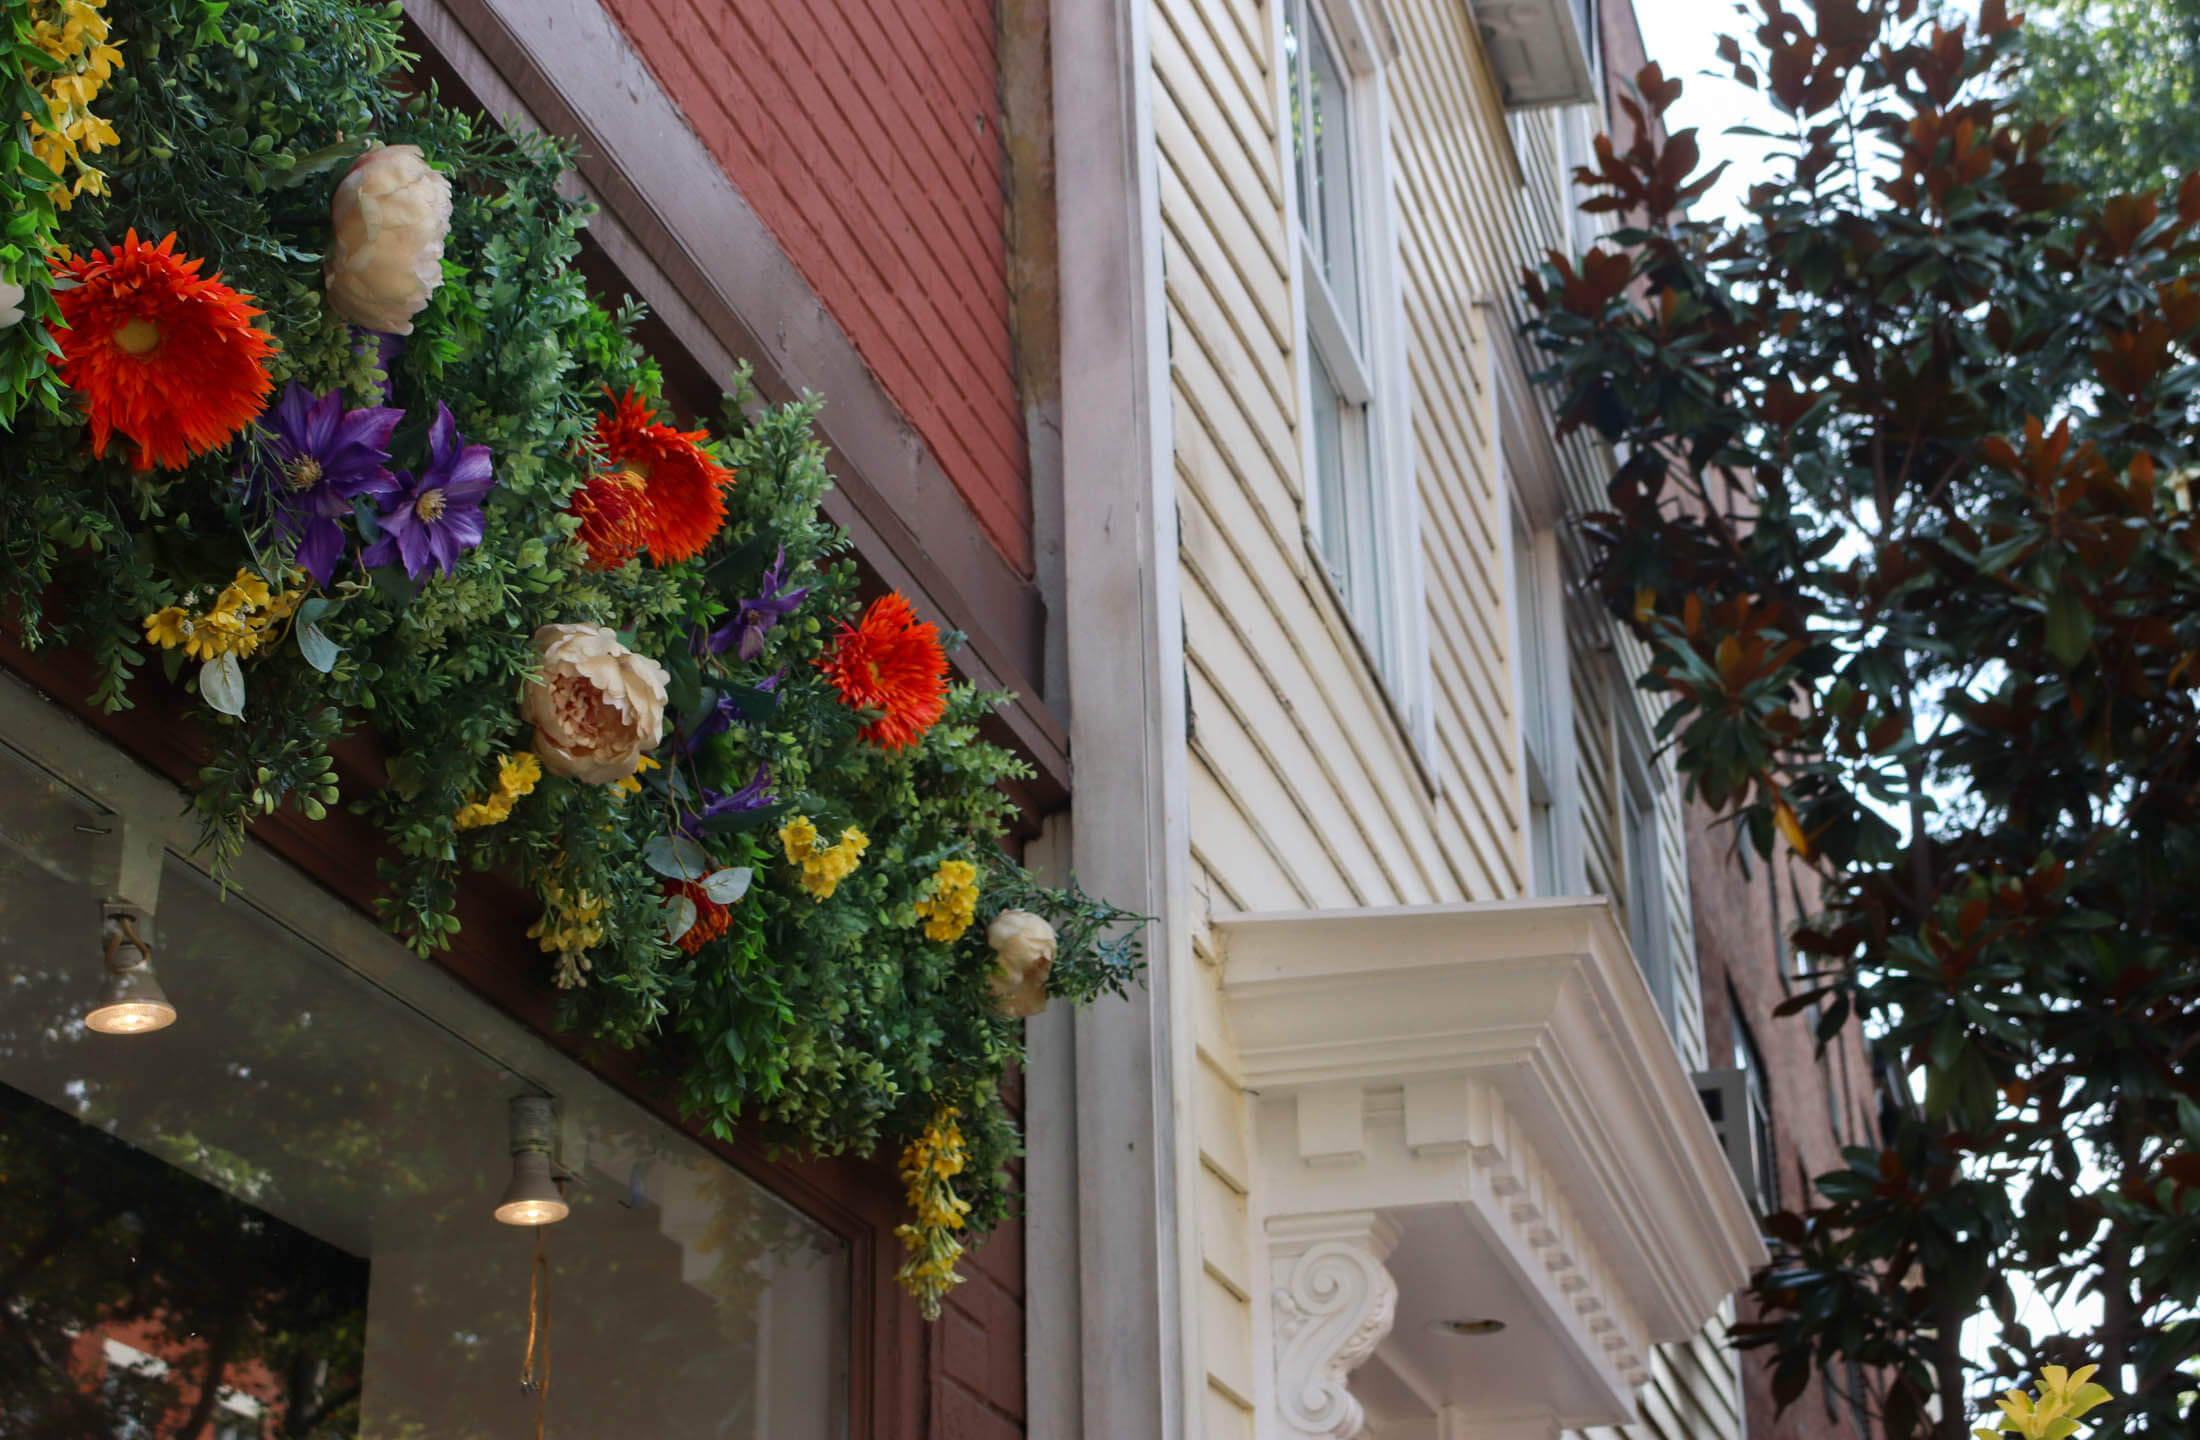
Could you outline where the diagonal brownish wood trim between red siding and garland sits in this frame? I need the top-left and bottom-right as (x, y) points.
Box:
(407, 0), (1069, 809)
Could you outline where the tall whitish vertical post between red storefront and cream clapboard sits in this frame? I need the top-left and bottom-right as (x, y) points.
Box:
(1027, 0), (1199, 1440)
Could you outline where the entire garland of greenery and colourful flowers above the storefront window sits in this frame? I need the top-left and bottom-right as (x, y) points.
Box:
(0, 0), (1140, 1315)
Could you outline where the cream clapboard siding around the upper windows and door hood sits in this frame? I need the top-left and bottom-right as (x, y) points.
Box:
(1148, 0), (1740, 1440)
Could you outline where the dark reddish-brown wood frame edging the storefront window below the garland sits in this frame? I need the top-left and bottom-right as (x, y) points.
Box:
(0, 629), (937, 1440)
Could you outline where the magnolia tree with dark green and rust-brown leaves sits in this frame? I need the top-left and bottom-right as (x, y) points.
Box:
(1527, 0), (2200, 1440)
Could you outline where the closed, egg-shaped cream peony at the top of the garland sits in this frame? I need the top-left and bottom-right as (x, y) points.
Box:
(321, 145), (451, 334)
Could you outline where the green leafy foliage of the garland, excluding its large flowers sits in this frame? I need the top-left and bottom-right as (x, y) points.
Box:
(0, 0), (1142, 1312)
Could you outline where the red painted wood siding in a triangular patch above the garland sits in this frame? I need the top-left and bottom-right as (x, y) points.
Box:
(603, 0), (1032, 574)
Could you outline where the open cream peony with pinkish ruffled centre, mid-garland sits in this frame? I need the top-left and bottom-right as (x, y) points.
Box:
(519, 624), (669, 785)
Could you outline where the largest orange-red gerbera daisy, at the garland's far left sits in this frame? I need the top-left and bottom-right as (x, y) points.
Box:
(53, 231), (275, 470)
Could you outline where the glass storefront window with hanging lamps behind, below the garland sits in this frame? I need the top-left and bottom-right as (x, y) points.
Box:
(0, 754), (849, 1440)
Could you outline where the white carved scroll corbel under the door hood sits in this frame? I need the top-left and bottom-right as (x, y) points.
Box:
(1267, 1211), (1397, 1440)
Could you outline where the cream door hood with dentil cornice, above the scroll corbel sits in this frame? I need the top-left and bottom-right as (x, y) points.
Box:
(1214, 899), (1767, 1425)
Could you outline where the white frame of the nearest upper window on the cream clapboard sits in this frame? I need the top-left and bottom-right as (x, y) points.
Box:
(1274, 0), (1434, 756)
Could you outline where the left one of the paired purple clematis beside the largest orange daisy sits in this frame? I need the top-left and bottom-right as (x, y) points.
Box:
(251, 380), (405, 585)
